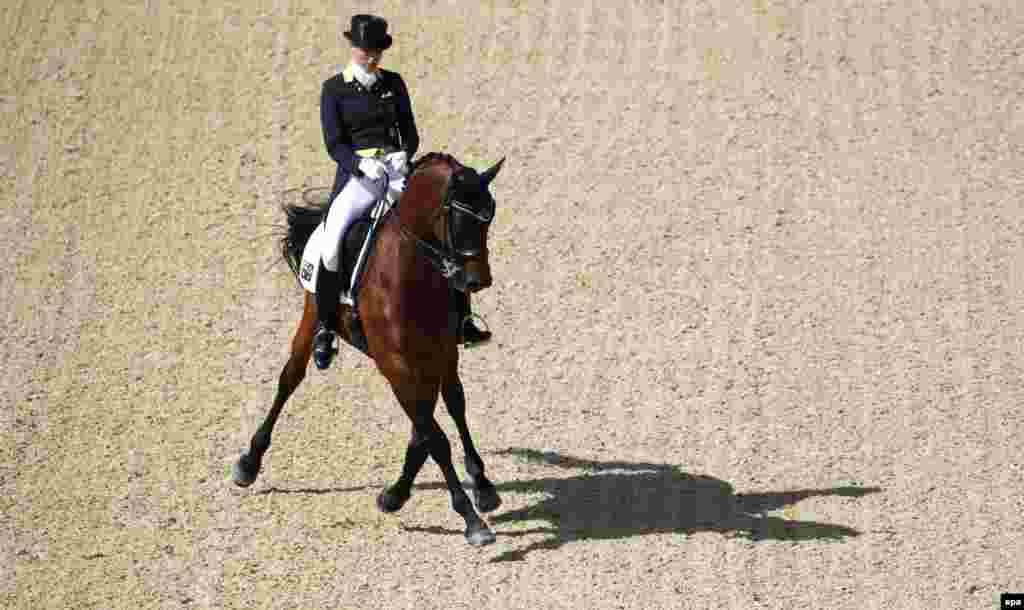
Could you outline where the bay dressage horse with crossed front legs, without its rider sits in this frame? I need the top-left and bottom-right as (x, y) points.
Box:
(232, 153), (505, 546)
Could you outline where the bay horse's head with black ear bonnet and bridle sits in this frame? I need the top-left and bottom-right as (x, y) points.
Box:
(405, 157), (505, 293)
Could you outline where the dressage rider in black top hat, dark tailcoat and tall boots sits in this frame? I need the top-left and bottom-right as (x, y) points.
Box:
(313, 14), (490, 369)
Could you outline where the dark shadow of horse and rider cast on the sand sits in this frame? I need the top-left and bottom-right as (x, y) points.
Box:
(256, 448), (881, 562)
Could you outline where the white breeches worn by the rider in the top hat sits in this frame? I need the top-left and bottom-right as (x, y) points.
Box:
(321, 166), (406, 271)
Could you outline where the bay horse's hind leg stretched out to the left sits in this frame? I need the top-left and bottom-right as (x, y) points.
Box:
(232, 293), (316, 487)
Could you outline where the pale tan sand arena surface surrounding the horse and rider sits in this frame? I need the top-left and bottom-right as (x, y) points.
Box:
(0, 0), (1024, 609)
